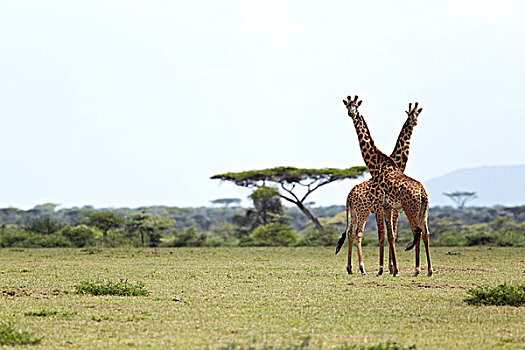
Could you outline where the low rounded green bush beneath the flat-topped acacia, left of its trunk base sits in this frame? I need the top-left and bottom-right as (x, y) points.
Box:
(241, 222), (299, 247)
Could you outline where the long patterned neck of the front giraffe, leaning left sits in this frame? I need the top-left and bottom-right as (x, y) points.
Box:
(352, 115), (392, 177)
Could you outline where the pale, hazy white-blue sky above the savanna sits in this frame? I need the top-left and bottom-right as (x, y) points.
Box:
(0, 0), (525, 208)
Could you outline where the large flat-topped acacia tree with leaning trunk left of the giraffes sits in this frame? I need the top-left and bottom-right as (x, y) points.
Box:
(211, 166), (368, 231)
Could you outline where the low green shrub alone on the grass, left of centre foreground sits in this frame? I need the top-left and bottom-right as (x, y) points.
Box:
(75, 279), (150, 296)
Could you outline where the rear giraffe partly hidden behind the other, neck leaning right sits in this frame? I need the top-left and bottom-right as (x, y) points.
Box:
(335, 102), (423, 275)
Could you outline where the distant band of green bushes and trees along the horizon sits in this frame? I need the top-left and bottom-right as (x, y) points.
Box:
(0, 204), (525, 247)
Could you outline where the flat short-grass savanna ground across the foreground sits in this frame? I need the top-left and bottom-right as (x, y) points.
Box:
(0, 247), (525, 349)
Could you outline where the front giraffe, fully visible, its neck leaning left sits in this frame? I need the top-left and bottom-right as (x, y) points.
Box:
(343, 96), (433, 277)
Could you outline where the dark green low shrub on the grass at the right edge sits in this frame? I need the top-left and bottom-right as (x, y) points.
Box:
(464, 283), (525, 306)
